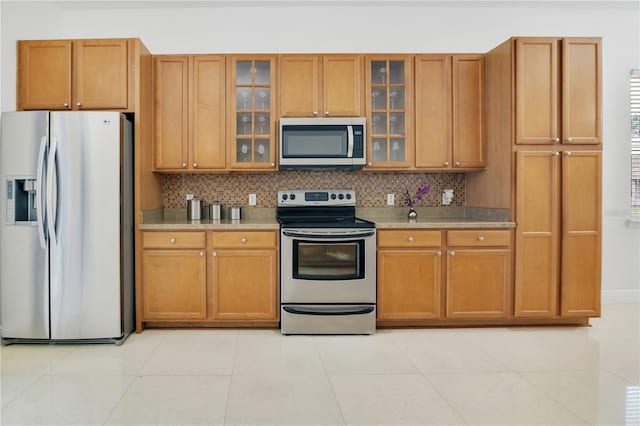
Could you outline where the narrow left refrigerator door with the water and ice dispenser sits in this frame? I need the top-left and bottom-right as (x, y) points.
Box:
(0, 111), (49, 339)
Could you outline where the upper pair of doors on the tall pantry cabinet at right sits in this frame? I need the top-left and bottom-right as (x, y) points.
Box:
(515, 37), (602, 145)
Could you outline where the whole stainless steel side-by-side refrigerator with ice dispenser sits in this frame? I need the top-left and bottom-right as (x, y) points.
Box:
(0, 111), (134, 344)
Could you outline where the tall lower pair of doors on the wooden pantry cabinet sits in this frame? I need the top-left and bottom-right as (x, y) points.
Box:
(515, 151), (601, 317)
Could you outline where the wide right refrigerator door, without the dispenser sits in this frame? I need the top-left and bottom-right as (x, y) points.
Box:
(47, 112), (123, 340)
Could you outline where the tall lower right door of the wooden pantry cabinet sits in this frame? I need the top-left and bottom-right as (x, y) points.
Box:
(560, 151), (602, 317)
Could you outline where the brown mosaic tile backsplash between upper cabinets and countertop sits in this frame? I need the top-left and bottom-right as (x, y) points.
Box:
(162, 171), (465, 208)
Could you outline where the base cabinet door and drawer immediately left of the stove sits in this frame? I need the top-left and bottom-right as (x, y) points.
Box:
(211, 231), (279, 321)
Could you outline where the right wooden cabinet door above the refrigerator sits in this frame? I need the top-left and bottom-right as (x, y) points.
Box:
(73, 39), (129, 110)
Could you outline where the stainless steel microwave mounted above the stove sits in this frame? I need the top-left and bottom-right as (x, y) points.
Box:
(279, 117), (366, 170)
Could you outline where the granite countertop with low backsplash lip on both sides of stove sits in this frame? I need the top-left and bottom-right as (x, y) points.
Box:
(139, 207), (516, 231)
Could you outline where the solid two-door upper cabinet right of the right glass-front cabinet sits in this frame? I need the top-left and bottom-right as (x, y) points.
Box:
(415, 55), (486, 170)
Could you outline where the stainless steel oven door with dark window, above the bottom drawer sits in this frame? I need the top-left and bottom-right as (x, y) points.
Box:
(280, 228), (376, 303)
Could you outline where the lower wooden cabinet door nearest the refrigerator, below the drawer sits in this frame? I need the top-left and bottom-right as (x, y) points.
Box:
(142, 250), (207, 320)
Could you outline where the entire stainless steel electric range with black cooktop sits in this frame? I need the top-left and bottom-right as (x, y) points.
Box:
(277, 190), (376, 334)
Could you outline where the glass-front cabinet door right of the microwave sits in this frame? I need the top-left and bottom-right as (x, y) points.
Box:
(366, 55), (413, 169)
